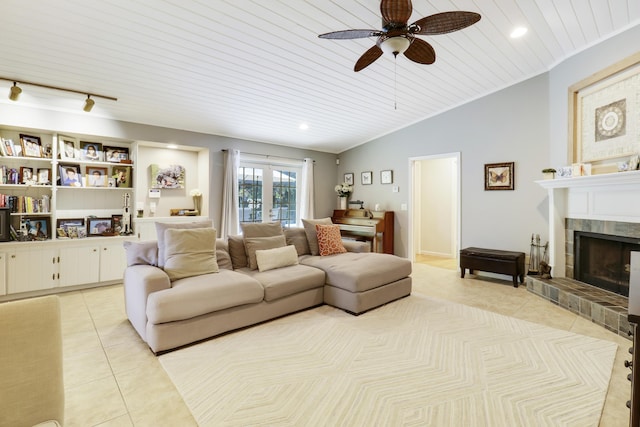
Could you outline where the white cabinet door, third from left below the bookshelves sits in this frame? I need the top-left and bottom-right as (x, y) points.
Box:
(60, 246), (100, 286)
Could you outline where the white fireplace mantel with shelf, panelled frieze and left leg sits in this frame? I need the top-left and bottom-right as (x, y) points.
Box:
(536, 171), (640, 277)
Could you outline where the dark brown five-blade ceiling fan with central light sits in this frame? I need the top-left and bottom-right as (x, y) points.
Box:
(318, 0), (480, 72)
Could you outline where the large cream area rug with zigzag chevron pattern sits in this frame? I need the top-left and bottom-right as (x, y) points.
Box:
(160, 294), (617, 427)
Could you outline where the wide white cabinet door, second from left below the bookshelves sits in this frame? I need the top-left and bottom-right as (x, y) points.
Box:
(7, 249), (58, 294)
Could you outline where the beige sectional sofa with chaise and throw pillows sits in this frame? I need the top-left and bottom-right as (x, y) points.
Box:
(124, 220), (411, 353)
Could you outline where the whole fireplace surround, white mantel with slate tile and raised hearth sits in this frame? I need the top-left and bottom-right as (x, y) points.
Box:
(527, 171), (640, 338)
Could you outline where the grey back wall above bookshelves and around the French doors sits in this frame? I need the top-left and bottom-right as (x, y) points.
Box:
(0, 100), (337, 232)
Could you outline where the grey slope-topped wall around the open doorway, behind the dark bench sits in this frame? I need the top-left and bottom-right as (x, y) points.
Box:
(339, 74), (549, 257)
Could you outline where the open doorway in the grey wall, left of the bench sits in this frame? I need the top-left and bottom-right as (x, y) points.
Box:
(409, 152), (460, 268)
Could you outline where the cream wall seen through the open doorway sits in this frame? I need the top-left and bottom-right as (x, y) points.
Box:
(414, 157), (457, 258)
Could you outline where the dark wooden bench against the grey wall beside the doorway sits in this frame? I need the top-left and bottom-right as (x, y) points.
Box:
(460, 248), (524, 288)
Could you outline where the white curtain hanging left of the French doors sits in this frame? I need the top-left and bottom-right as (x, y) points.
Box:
(220, 150), (240, 239)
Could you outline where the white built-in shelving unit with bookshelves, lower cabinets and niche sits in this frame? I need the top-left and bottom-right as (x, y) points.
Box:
(0, 125), (209, 301)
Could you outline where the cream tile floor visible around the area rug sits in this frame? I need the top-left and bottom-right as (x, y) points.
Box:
(60, 256), (630, 427)
